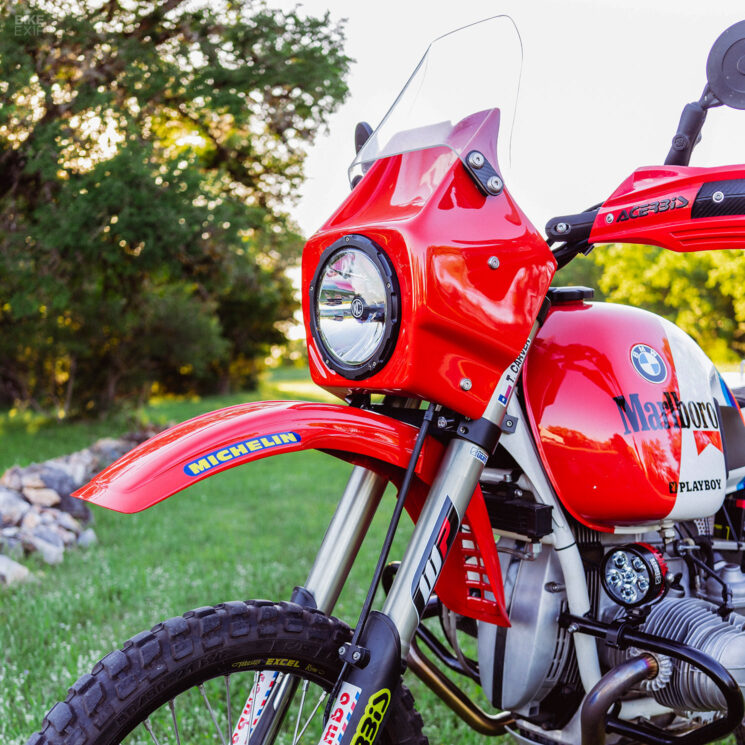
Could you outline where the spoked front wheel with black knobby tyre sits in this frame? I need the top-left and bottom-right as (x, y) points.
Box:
(27, 601), (427, 745)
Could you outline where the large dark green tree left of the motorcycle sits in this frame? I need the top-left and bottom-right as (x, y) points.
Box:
(0, 0), (349, 413)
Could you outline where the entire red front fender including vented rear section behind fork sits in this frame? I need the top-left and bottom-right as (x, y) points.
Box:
(73, 401), (509, 626)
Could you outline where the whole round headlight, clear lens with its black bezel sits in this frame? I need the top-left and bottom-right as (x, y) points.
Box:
(310, 235), (399, 380)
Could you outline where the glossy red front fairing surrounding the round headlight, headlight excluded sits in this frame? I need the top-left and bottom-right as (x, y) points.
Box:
(303, 111), (556, 418)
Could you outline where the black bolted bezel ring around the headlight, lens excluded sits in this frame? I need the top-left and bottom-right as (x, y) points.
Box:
(308, 234), (401, 380)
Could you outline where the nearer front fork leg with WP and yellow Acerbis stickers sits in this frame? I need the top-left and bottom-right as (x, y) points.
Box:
(319, 439), (488, 745)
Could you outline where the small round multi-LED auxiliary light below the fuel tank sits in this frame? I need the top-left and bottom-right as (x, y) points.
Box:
(600, 543), (667, 608)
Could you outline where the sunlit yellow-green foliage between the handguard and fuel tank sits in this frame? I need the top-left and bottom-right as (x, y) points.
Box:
(555, 244), (745, 363)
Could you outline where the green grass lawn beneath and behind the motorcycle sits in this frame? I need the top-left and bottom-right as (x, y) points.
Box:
(0, 373), (732, 745)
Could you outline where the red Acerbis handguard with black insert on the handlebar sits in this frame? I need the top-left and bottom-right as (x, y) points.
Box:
(589, 165), (745, 251)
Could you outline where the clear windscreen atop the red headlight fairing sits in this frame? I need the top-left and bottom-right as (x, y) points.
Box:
(349, 16), (522, 183)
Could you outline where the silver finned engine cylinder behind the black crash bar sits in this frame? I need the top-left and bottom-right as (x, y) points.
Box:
(608, 598), (745, 714)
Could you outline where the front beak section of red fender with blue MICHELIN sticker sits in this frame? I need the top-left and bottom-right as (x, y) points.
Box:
(74, 401), (442, 512)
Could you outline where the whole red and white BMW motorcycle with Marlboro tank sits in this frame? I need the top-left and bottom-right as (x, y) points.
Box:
(29, 16), (745, 745)
